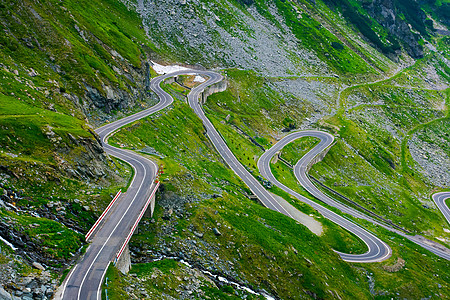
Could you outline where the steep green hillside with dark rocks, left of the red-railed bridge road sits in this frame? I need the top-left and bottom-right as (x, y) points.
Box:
(0, 1), (149, 291)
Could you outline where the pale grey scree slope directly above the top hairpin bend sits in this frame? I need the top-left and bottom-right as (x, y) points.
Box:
(124, 0), (329, 76)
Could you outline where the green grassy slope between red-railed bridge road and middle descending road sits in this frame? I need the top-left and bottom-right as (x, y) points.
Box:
(111, 92), (376, 298)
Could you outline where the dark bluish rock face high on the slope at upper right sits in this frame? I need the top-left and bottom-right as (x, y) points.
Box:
(366, 0), (426, 58)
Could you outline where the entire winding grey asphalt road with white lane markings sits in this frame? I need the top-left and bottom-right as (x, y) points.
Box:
(61, 70), (450, 300)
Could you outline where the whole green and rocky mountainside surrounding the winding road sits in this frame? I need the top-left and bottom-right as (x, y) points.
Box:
(0, 0), (450, 299)
